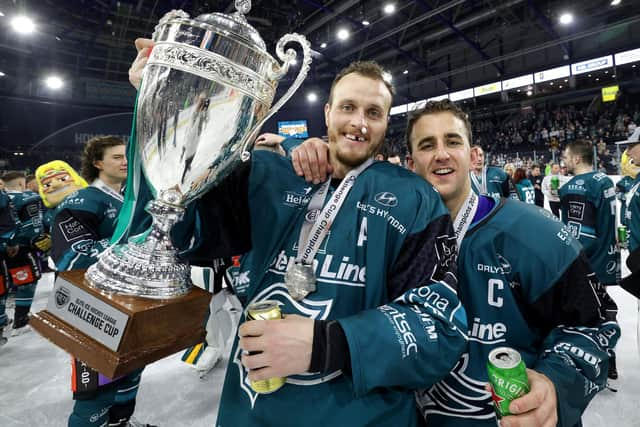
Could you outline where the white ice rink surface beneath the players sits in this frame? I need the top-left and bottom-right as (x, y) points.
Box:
(0, 256), (640, 427)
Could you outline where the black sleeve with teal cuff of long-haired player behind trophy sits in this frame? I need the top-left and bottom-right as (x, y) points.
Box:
(51, 209), (109, 271)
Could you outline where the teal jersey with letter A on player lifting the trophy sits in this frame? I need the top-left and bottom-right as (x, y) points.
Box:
(122, 151), (466, 427)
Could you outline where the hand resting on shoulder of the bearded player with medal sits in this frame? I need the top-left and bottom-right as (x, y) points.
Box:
(291, 138), (333, 184)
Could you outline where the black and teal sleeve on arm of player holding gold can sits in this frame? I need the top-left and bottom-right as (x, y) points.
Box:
(339, 189), (467, 396)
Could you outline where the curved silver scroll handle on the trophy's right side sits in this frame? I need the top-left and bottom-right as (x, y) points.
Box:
(241, 33), (311, 162)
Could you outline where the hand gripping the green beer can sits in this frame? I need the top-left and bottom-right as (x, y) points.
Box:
(492, 369), (558, 427)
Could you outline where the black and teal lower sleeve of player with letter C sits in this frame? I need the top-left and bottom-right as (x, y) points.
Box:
(529, 252), (620, 427)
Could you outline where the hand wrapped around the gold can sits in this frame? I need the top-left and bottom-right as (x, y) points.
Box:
(238, 315), (314, 381)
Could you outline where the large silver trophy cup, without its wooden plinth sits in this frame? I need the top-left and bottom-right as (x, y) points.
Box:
(85, 0), (311, 299)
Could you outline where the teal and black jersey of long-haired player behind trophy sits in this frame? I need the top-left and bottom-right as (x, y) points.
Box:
(51, 186), (122, 271)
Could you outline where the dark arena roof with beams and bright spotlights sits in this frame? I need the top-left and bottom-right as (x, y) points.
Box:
(0, 0), (640, 108)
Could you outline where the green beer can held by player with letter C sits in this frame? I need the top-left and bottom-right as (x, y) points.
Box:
(487, 347), (531, 418)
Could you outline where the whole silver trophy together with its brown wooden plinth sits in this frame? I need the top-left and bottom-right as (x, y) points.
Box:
(30, 0), (311, 378)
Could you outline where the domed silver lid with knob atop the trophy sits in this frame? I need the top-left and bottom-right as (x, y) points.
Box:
(195, 0), (267, 51)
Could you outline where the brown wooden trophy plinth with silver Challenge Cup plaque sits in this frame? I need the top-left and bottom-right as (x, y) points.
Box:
(29, 270), (211, 378)
